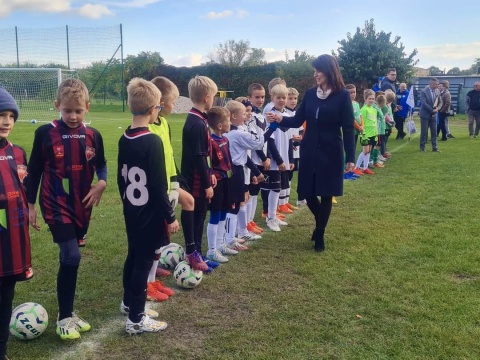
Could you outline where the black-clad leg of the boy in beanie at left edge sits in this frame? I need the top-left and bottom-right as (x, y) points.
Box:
(0, 276), (16, 360)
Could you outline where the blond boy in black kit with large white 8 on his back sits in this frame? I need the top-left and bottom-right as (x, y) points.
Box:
(117, 78), (179, 335)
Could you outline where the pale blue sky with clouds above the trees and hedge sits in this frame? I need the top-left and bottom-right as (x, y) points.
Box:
(0, 0), (480, 71)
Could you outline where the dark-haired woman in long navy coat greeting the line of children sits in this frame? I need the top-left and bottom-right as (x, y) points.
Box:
(267, 54), (355, 251)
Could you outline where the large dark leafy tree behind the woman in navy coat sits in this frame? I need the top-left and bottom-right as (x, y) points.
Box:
(332, 19), (418, 93)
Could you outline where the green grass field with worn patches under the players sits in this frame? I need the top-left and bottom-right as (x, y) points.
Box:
(9, 112), (480, 360)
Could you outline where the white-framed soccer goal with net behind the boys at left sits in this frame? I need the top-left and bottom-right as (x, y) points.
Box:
(0, 68), (78, 122)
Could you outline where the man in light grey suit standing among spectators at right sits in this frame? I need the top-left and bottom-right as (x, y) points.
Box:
(420, 78), (442, 152)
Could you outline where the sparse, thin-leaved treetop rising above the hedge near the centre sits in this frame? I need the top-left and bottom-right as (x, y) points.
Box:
(208, 40), (266, 66)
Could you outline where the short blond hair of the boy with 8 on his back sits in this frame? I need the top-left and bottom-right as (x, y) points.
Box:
(127, 78), (162, 113)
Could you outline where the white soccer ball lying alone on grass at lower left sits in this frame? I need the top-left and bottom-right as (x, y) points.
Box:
(9, 302), (48, 340)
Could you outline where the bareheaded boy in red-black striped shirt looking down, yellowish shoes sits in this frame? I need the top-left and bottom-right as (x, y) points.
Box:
(26, 79), (107, 340)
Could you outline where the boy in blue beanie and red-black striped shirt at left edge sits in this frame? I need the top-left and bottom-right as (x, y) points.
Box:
(0, 88), (33, 360)
